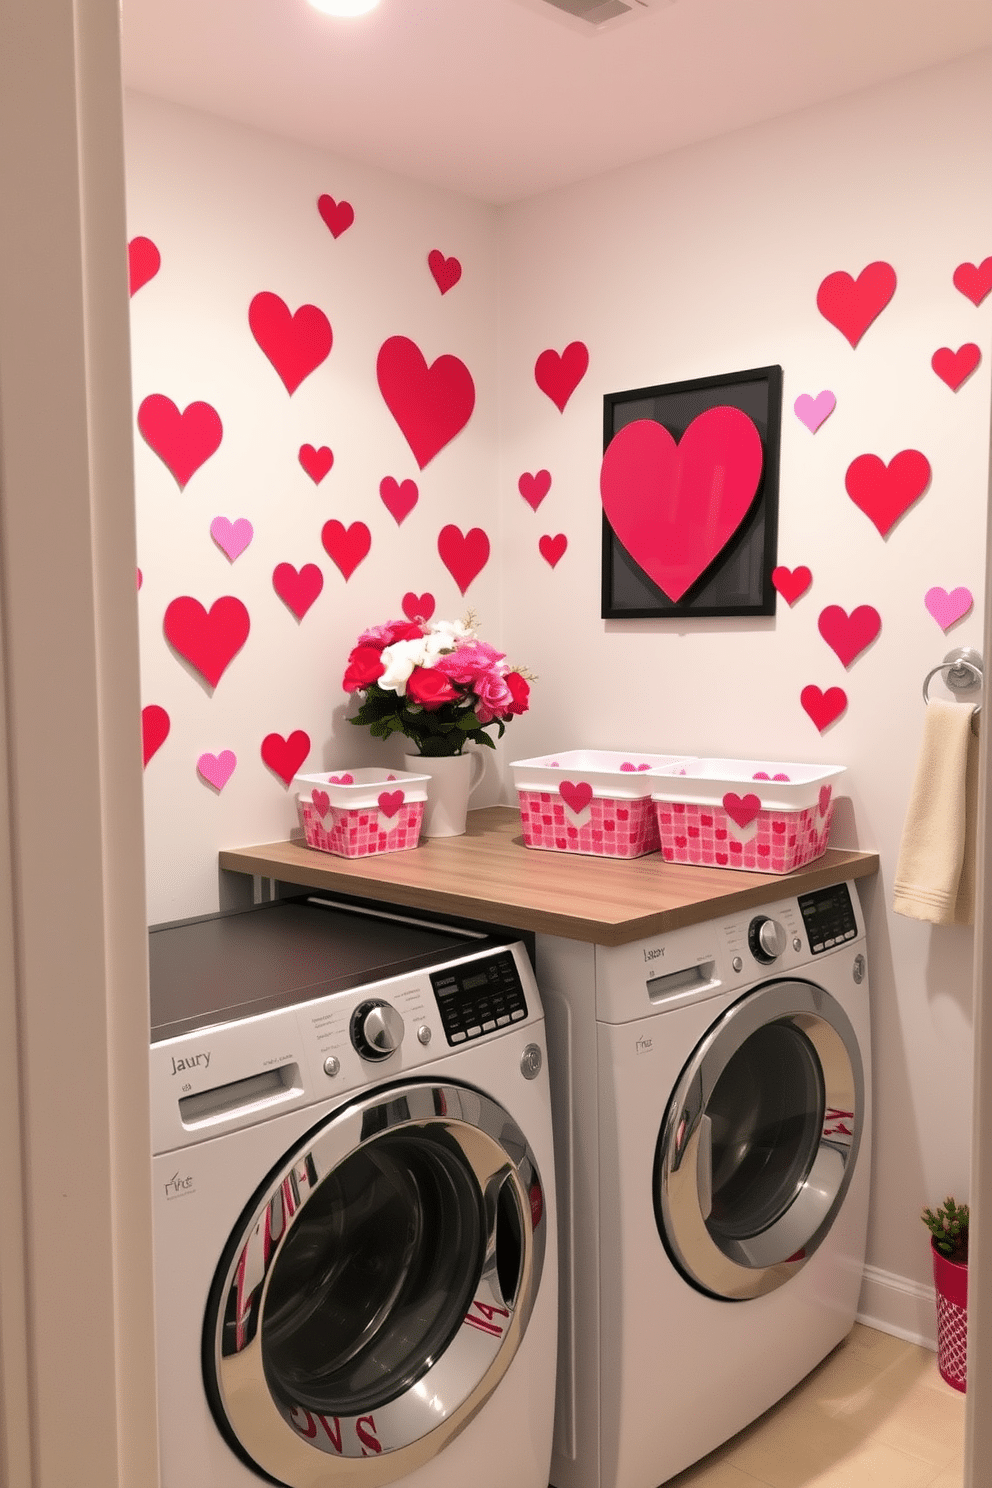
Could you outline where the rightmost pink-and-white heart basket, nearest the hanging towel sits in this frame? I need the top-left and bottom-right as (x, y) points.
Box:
(651, 759), (845, 873)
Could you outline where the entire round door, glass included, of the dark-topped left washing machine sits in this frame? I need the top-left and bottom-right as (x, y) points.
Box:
(204, 1082), (546, 1488)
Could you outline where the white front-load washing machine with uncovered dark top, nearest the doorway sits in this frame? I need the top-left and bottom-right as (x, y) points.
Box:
(150, 897), (558, 1488)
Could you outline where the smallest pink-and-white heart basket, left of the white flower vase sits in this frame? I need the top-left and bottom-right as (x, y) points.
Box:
(293, 768), (428, 857)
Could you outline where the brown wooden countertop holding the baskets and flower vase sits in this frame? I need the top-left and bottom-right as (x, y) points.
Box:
(220, 806), (879, 945)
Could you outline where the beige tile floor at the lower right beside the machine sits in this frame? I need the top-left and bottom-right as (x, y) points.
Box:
(665, 1324), (964, 1488)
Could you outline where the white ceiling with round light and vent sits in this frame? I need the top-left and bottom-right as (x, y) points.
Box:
(123, 0), (992, 204)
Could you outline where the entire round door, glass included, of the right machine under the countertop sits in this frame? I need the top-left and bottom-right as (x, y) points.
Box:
(654, 981), (864, 1301)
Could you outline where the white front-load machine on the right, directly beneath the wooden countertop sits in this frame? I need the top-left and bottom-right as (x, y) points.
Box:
(537, 882), (872, 1488)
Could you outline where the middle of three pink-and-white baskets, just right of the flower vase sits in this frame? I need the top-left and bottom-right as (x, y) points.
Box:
(510, 750), (699, 857)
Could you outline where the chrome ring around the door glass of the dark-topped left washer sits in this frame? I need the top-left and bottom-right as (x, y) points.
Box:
(204, 1082), (546, 1488)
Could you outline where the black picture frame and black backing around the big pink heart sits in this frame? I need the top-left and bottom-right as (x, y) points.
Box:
(602, 366), (782, 620)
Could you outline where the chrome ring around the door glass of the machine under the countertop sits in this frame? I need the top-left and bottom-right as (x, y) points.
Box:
(654, 981), (864, 1301)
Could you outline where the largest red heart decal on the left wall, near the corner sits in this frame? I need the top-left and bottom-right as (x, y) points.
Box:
(375, 336), (476, 470)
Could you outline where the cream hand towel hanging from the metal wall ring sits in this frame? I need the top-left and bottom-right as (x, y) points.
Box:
(892, 698), (979, 926)
